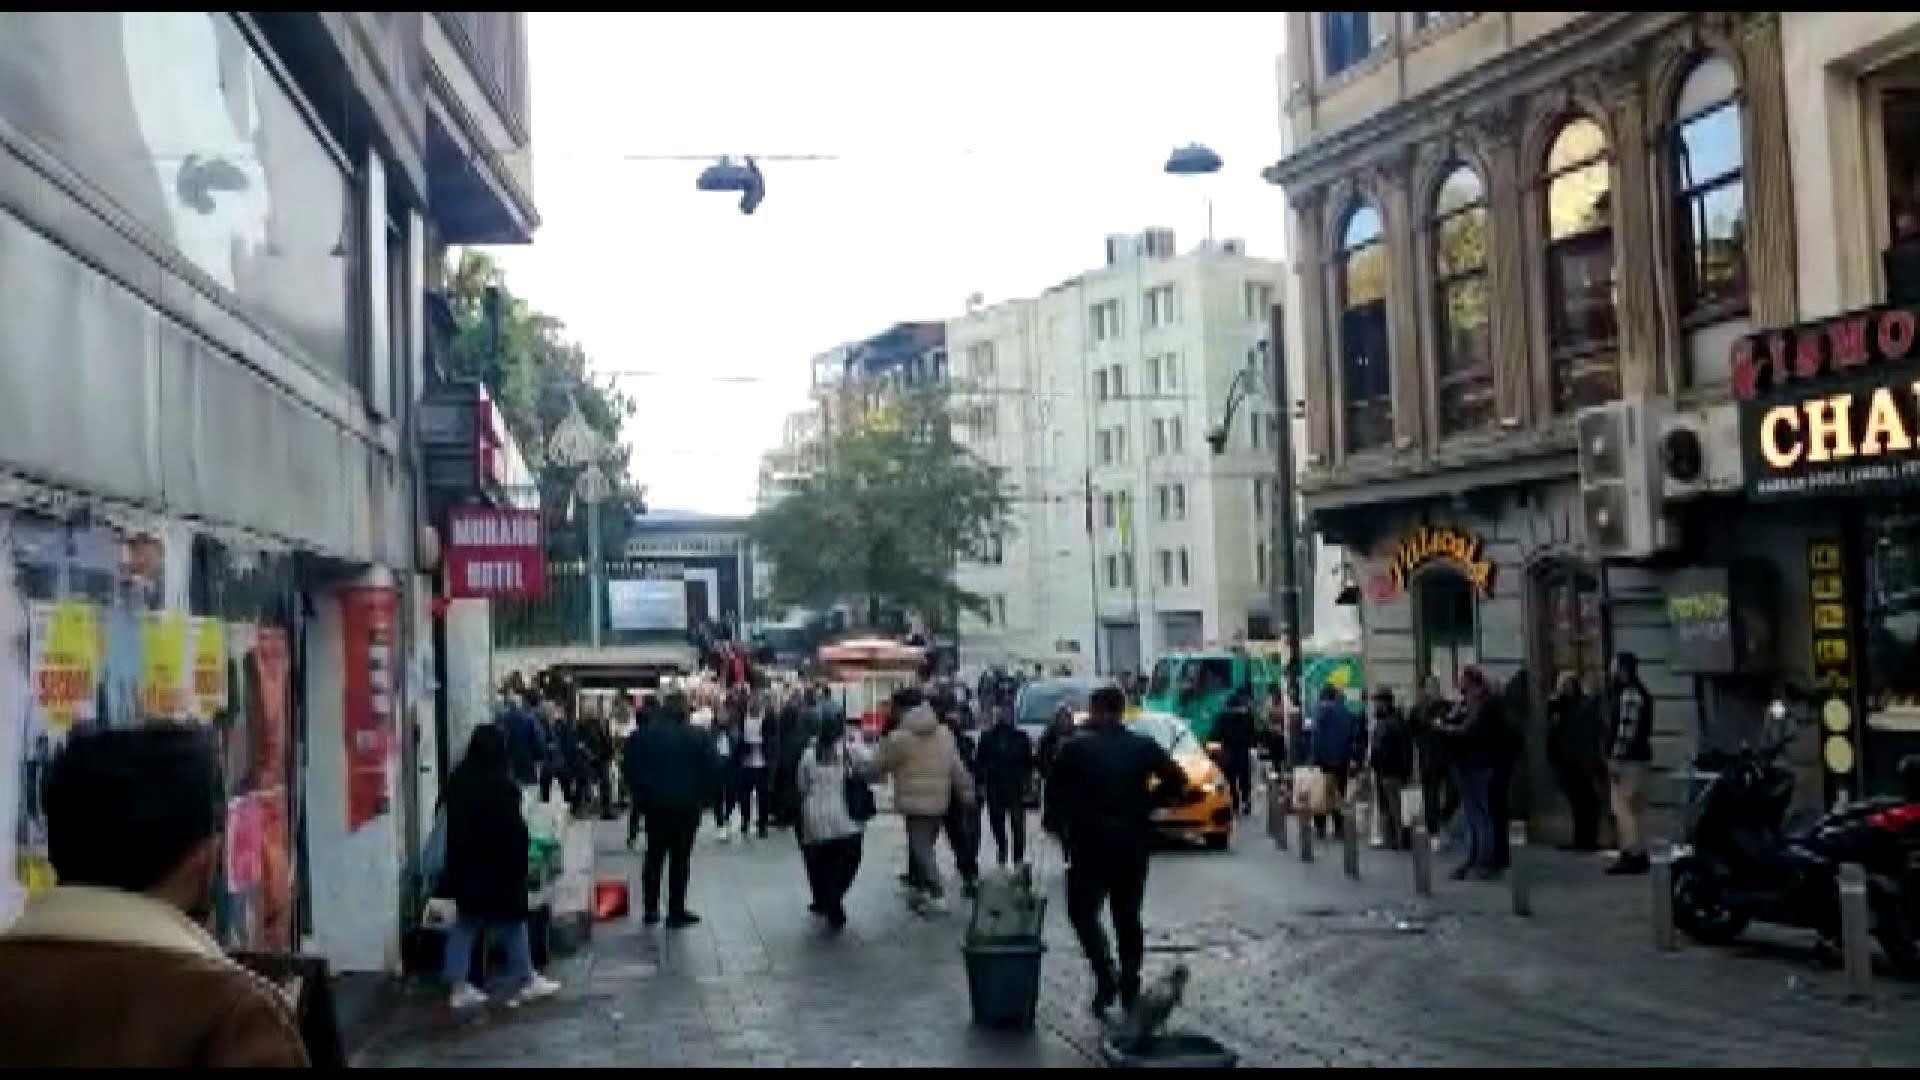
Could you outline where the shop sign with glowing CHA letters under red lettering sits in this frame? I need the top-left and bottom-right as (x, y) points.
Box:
(1730, 299), (1920, 500)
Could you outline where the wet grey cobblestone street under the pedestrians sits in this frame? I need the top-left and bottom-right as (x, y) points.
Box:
(361, 803), (1920, 1068)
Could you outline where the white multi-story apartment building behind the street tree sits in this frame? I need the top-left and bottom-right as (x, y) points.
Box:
(947, 229), (1331, 673)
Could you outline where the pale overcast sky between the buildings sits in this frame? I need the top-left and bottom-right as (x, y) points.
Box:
(505, 12), (1286, 513)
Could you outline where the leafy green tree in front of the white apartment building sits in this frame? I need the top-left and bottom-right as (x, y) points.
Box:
(751, 386), (1012, 628)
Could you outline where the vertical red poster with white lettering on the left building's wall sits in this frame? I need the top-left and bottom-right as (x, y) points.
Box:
(340, 588), (397, 832)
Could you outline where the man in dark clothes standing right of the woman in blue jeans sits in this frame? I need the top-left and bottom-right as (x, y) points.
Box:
(634, 694), (720, 928)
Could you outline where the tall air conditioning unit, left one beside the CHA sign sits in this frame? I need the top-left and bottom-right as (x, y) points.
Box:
(1574, 398), (1674, 559)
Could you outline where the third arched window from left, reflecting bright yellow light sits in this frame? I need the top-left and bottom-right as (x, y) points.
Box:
(1540, 117), (1620, 413)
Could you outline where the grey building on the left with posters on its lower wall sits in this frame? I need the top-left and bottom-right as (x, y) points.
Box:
(0, 12), (536, 970)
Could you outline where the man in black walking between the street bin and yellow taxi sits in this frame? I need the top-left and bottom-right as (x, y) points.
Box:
(1043, 686), (1187, 1013)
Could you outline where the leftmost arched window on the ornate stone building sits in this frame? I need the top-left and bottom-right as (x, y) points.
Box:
(1334, 202), (1394, 452)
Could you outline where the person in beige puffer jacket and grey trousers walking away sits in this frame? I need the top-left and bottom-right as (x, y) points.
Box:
(874, 688), (973, 913)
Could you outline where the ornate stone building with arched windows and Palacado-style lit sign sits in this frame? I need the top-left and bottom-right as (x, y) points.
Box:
(1267, 12), (1812, 834)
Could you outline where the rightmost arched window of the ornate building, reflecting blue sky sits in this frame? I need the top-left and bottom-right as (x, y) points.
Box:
(1672, 56), (1747, 325)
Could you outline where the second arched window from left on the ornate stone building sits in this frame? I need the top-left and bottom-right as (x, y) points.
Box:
(1428, 165), (1496, 436)
